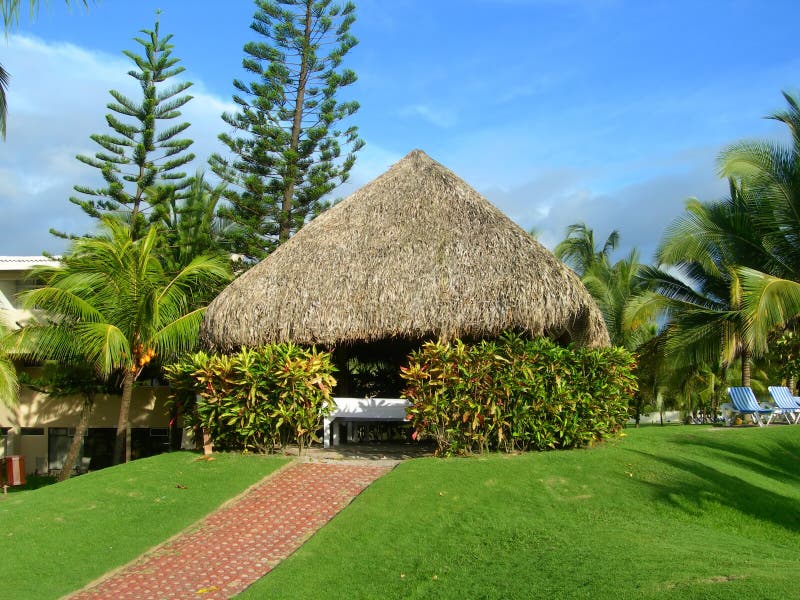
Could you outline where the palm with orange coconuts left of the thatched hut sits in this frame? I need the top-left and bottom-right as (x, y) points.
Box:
(18, 219), (229, 463)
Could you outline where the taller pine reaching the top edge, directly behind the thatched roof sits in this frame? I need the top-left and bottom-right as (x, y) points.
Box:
(209, 0), (364, 261)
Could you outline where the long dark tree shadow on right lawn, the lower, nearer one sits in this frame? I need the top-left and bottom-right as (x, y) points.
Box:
(628, 446), (800, 533)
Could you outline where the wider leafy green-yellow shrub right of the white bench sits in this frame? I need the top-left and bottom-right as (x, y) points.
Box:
(402, 334), (636, 455)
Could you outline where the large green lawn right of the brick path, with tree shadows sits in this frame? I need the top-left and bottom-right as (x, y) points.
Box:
(241, 426), (800, 599)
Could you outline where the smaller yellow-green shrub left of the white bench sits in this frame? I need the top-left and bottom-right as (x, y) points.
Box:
(165, 343), (336, 452)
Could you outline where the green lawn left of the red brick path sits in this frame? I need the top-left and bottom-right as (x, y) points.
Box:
(0, 452), (286, 599)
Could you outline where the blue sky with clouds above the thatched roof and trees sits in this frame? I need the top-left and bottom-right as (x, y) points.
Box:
(0, 0), (800, 260)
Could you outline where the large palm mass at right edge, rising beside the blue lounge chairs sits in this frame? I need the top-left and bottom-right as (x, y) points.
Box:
(628, 93), (800, 398)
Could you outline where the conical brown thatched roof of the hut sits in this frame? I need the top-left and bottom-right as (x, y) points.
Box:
(200, 150), (609, 351)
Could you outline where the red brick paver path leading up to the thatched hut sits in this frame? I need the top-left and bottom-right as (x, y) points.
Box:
(70, 462), (388, 600)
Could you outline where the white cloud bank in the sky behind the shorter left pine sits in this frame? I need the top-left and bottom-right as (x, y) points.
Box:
(0, 35), (233, 255)
